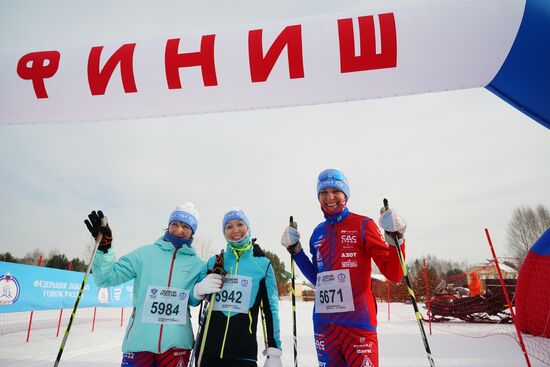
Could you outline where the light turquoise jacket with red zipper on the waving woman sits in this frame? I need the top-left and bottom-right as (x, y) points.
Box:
(92, 237), (205, 353)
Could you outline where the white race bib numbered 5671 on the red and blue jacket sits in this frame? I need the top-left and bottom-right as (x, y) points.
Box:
(315, 269), (355, 313)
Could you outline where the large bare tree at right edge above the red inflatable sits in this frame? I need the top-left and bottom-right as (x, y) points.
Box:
(507, 205), (550, 259)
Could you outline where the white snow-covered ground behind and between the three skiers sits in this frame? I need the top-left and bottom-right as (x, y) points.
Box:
(0, 300), (547, 367)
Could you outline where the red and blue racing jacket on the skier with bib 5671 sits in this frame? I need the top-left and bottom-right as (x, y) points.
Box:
(295, 208), (405, 331)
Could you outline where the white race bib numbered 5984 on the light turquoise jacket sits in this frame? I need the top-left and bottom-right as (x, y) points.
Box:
(141, 285), (189, 325)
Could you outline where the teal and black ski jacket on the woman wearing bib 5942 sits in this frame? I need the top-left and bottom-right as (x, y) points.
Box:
(197, 245), (281, 361)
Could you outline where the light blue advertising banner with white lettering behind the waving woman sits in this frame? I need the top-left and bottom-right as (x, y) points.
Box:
(0, 261), (134, 313)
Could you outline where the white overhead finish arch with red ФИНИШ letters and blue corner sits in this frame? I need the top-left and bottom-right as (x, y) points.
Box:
(0, 0), (550, 128)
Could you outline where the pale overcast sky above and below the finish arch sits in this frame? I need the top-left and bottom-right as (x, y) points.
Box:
(0, 0), (550, 274)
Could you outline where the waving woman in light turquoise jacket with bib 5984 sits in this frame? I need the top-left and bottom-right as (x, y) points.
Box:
(85, 203), (217, 367)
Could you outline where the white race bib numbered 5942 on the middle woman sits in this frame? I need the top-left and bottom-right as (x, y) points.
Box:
(213, 275), (252, 313)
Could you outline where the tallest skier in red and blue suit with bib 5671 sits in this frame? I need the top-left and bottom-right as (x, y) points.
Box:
(281, 169), (406, 367)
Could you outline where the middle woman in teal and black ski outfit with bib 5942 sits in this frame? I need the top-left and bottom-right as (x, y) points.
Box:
(194, 208), (282, 367)
